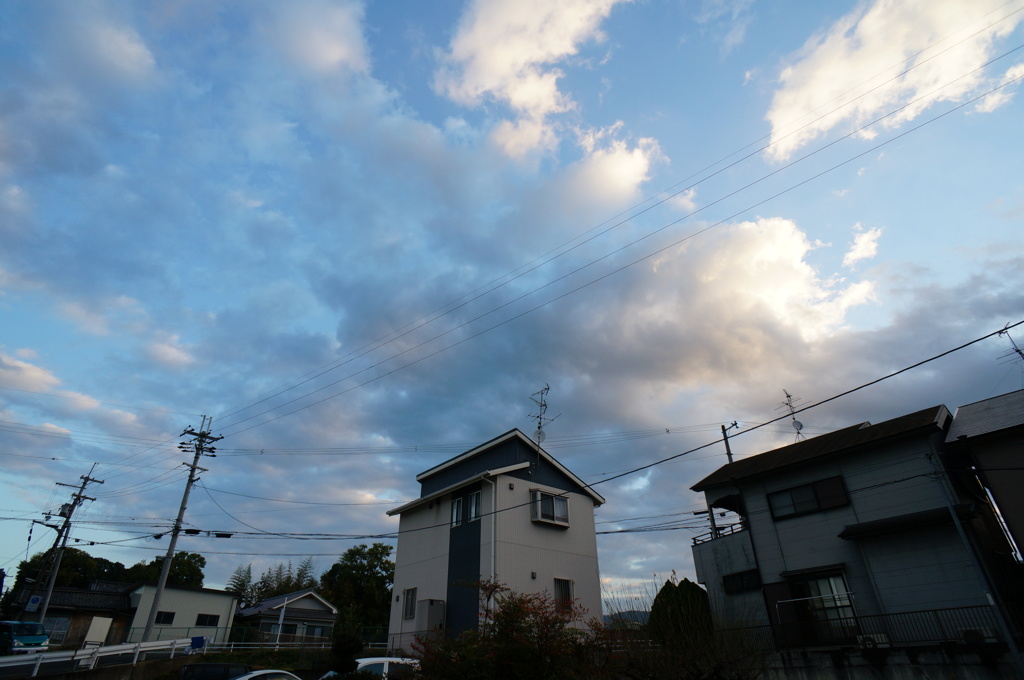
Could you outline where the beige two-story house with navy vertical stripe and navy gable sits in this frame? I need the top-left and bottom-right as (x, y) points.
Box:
(388, 429), (604, 650)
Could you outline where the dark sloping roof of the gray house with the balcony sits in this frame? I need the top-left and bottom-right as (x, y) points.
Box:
(690, 406), (950, 492)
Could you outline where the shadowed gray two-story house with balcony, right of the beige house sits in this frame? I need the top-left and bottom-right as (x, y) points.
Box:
(693, 406), (1009, 649)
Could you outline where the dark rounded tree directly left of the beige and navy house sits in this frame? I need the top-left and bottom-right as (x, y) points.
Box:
(321, 543), (394, 633)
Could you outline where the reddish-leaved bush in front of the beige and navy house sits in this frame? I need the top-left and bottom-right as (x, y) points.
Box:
(413, 581), (614, 680)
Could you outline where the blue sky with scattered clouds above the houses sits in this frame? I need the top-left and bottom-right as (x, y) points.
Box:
(0, 0), (1024, 606)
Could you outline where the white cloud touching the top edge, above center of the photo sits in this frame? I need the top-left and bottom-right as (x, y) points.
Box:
(434, 0), (620, 157)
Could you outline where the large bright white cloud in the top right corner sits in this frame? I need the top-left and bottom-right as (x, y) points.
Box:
(767, 0), (1022, 161)
